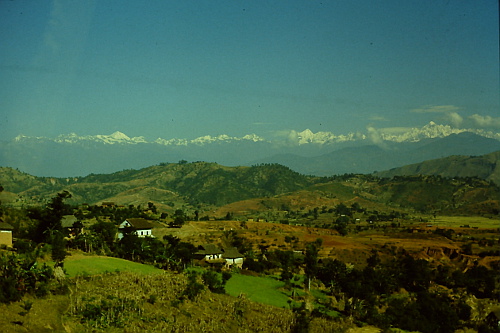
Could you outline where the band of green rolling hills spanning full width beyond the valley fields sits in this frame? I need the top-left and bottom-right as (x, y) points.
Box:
(0, 154), (500, 215)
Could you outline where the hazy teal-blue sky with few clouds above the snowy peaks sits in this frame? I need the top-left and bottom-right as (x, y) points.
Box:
(0, 0), (500, 140)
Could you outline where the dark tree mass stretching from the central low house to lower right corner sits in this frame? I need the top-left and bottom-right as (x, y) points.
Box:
(243, 240), (500, 333)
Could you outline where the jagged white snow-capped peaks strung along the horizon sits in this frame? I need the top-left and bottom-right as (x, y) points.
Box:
(9, 121), (500, 146)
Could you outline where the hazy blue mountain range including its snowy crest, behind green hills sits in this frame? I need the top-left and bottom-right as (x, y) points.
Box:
(0, 122), (500, 177)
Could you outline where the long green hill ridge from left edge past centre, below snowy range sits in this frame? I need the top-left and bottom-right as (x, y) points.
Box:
(0, 162), (321, 205)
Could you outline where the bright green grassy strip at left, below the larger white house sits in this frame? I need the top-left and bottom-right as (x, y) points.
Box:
(60, 257), (163, 277)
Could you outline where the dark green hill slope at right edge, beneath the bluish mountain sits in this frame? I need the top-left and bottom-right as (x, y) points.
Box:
(375, 151), (500, 185)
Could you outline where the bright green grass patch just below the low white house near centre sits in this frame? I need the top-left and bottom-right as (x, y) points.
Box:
(226, 274), (289, 308)
